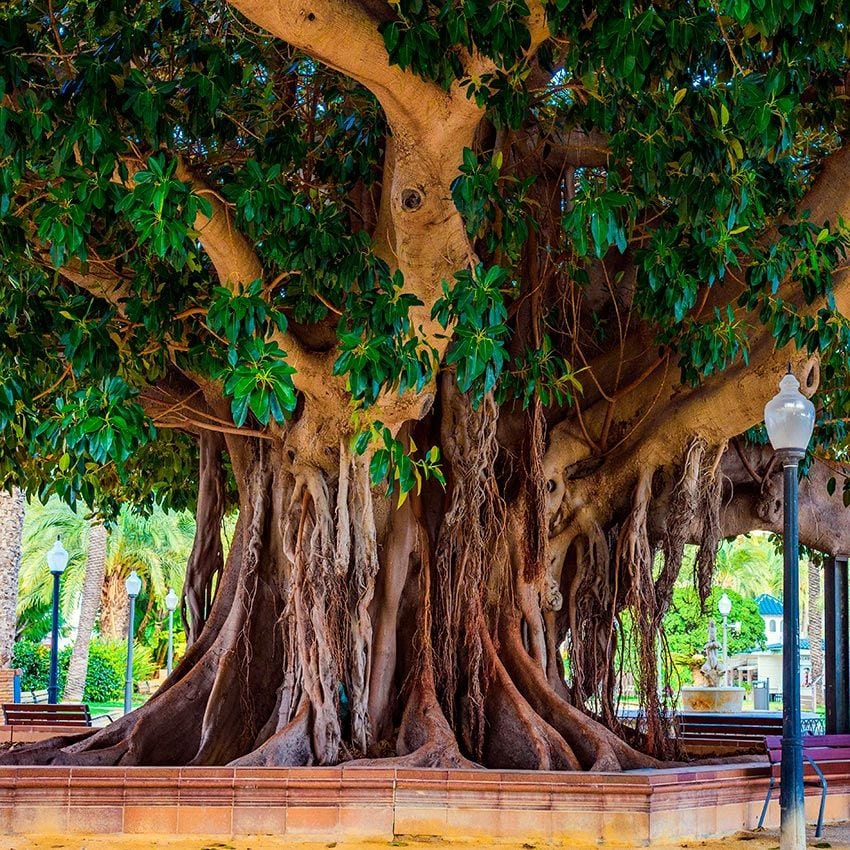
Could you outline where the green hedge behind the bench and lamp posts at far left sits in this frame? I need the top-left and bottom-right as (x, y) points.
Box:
(12, 640), (154, 702)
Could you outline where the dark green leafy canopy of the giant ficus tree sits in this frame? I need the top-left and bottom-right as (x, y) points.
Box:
(0, 0), (850, 516)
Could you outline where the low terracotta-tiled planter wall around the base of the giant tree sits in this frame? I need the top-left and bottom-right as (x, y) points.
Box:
(0, 763), (850, 847)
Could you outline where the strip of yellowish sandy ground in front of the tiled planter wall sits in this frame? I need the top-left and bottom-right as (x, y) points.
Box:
(0, 824), (850, 850)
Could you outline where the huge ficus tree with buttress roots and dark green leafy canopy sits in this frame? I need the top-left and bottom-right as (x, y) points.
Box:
(0, 0), (850, 769)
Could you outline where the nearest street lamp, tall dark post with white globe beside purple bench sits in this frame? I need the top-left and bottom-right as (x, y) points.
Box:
(764, 365), (815, 850)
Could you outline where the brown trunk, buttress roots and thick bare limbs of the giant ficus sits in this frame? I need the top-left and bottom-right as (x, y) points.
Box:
(0, 0), (850, 771)
